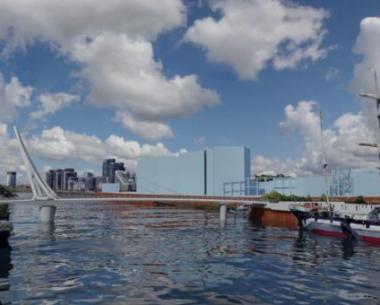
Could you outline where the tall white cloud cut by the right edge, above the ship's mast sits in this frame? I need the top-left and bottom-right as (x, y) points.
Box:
(350, 17), (380, 94)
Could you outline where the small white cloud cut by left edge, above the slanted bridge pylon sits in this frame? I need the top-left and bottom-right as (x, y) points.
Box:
(0, 73), (33, 121)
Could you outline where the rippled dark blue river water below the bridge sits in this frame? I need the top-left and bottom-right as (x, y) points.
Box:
(0, 203), (380, 305)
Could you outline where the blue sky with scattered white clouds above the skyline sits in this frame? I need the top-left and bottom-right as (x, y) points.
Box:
(0, 0), (380, 181)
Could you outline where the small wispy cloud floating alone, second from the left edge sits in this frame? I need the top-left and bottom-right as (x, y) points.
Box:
(29, 92), (79, 119)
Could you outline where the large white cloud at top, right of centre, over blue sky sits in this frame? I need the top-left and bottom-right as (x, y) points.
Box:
(185, 0), (329, 79)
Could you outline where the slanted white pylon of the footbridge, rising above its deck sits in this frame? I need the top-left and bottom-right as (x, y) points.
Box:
(13, 127), (58, 200)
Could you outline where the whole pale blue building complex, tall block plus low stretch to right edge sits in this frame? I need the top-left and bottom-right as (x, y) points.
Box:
(136, 147), (380, 197)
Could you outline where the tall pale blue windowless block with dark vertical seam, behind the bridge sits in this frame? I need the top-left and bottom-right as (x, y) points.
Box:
(136, 146), (251, 195)
